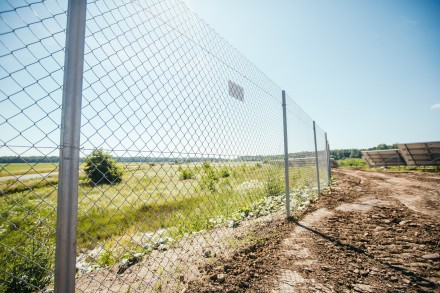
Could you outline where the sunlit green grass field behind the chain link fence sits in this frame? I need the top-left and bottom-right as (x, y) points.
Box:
(0, 162), (322, 290)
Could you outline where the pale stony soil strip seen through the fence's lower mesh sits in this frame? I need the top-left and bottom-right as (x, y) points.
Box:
(75, 213), (282, 292)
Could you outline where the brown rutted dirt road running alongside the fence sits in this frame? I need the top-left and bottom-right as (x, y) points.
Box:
(188, 170), (440, 292)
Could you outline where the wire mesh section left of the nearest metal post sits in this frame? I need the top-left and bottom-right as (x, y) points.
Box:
(0, 1), (66, 292)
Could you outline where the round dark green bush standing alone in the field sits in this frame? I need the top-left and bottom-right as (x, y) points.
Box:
(84, 150), (122, 185)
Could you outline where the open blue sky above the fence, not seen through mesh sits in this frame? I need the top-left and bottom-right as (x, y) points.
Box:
(186, 0), (440, 149)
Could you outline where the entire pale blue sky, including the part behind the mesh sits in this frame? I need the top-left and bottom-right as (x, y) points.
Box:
(0, 0), (440, 158)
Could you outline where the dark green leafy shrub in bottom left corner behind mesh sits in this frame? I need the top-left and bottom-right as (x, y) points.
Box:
(0, 236), (52, 292)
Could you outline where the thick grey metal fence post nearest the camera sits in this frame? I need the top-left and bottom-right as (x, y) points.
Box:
(55, 0), (87, 292)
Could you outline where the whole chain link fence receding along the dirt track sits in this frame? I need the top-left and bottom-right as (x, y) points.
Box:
(0, 0), (330, 292)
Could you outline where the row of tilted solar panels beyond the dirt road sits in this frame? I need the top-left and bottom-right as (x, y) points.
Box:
(362, 141), (440, 167)
